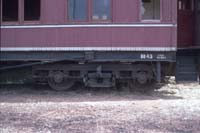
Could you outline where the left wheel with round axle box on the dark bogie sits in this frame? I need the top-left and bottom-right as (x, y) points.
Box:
(48, 71), (74, 91)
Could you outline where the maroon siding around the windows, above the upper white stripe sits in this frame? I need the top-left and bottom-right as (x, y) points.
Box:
(1, 0), (177, 25)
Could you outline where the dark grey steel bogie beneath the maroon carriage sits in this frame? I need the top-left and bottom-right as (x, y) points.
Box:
(33, 63), (156, 90)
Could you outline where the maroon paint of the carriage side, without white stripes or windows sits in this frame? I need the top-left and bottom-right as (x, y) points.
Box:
(1, 0), (177, 50)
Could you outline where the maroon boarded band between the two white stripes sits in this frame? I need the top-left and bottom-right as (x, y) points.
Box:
(1, 27), (176, 47)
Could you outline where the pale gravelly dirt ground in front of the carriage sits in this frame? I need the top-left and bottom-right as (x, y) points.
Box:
(0, 80), (200, 133)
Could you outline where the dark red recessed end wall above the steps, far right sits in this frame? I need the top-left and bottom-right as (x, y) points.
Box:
(177, 0), (200, 48)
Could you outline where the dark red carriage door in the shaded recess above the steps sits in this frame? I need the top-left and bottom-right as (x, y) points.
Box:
(178, 0), (194, 47)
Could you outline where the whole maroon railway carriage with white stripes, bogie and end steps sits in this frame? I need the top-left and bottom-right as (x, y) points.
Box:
(0, 0), (200, 90)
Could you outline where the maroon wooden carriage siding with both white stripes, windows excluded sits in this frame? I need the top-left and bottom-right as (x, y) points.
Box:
(1, 0), (177, 51)
